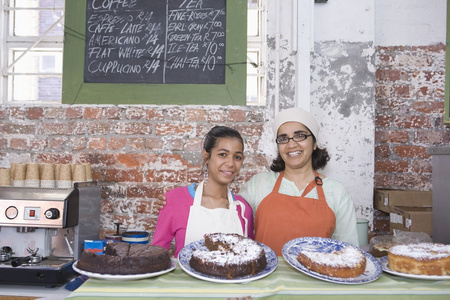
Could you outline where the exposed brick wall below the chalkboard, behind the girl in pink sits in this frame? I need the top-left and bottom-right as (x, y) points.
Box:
(0, 105), (267, 237)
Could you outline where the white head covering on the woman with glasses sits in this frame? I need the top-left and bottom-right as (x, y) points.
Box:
(272, 108), (320, 139)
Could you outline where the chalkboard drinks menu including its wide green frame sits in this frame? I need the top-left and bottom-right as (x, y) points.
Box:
(61, 0), (248, 105)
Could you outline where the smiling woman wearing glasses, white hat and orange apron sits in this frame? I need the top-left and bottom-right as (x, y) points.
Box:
(239, 108), (358, 255)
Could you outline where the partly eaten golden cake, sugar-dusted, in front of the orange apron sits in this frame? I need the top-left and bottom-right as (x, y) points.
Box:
(297, 246), (367, 278)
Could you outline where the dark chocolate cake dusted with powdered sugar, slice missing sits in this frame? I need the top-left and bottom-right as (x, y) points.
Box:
(189, 233), (267, 279)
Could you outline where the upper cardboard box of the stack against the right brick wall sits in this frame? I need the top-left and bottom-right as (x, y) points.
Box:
(374, 189), (433, 213)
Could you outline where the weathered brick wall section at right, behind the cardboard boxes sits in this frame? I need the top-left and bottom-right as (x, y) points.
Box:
(374, 44), (450, 231)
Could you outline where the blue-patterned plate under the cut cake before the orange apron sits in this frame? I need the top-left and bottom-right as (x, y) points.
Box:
(282, 237), (383, 284)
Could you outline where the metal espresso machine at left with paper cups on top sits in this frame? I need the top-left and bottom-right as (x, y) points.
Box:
(0, 182), (101, 288)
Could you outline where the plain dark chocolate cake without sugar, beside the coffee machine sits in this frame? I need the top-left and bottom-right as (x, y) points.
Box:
(77, 242), (171, 275)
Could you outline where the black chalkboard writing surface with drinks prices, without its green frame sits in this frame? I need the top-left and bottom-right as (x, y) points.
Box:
(84, 0), (226, 84)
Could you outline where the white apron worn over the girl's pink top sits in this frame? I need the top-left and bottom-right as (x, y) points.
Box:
(184, 181), (248, 246)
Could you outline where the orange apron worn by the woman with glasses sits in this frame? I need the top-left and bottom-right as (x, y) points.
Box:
(255, 172), (336, 256)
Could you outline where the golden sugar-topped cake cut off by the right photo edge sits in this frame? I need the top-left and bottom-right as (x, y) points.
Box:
(388, 243), (450, 275)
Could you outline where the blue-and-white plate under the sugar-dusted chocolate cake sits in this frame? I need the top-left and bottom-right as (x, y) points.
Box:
(178, 239), (278, 283)
